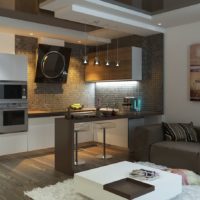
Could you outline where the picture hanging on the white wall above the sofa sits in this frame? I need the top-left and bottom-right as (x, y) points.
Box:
(190, 44), (200, 101)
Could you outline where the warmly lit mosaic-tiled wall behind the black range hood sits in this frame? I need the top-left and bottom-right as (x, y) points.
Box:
(15, 36), (95, 111)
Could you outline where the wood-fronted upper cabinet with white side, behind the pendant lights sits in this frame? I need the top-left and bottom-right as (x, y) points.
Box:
(85, 47), (142, 82)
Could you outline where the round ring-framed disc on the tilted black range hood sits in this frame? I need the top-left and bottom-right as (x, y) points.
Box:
(41, 51), (65, 79)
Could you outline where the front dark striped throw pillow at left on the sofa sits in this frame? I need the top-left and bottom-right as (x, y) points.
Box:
(162, 122), (187, 141)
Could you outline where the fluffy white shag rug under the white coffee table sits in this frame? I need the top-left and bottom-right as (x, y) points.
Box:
(24, 162), (200, 200)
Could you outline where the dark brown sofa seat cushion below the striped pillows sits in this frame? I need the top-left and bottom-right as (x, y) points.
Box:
(150, 141), (200, 172)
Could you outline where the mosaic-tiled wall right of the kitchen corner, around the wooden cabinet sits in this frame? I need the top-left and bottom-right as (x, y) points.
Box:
(95, 34), (164, 113)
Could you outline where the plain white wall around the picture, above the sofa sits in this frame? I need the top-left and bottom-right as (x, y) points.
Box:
(164, 22), (200, 125)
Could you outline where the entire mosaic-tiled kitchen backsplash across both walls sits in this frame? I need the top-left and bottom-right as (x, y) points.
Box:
(15, 34), (163, 113)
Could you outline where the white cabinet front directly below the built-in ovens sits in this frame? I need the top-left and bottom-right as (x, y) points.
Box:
(0, 132), (27, 156)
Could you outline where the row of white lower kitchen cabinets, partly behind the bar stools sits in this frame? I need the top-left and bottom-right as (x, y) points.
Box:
(0, 116), (161, 156)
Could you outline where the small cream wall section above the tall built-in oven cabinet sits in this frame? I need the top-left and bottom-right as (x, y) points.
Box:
(0, 33), (15, 54)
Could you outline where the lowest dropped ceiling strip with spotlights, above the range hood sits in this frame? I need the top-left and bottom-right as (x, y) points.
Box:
(0, 16), (111, 45)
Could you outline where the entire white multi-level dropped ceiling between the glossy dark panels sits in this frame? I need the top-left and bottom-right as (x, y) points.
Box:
(0, 0), (200, 45)
